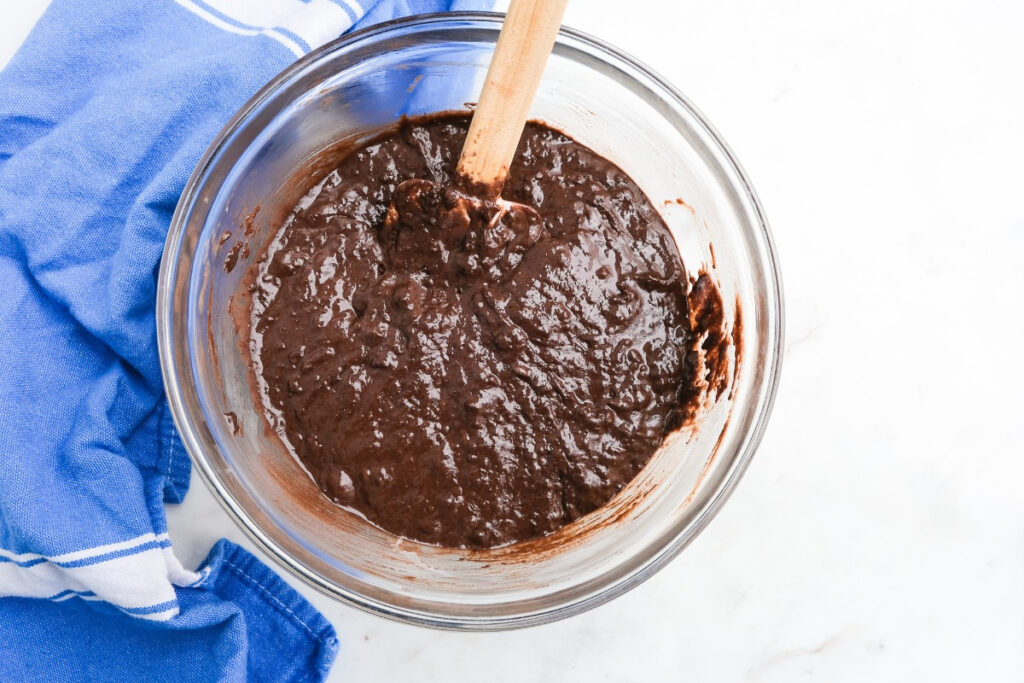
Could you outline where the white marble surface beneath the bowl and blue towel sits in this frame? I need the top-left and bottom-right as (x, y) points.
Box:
(0, 0), (1024, 683)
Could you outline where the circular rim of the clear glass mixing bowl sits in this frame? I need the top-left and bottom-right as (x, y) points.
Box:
(156, 11), (785, 631)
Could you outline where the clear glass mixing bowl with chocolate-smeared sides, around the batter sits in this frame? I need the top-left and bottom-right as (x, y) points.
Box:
(157, 13), (782, 630)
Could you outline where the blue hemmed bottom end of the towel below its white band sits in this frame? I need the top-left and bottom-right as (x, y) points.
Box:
(0, 541), (338, 683)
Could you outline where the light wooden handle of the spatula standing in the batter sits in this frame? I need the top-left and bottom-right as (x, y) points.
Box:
(457, 0), (568, 197)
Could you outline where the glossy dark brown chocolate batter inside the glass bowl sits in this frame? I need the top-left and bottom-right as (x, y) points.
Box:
(251, 115), (720, 547)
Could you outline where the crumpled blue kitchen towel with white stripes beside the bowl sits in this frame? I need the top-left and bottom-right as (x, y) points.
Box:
(0, 0), (492, 681)
